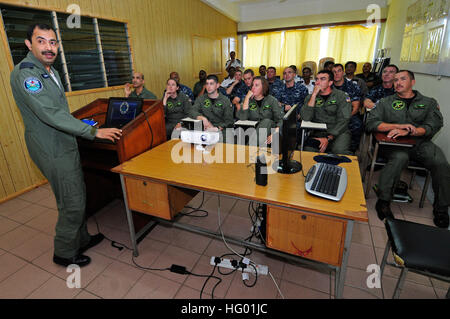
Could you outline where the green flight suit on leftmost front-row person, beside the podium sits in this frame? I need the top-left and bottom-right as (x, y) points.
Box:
(164, 92), (192, 139)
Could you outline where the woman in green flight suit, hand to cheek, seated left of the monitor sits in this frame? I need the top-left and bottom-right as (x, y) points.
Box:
(236, 76), (283, 144)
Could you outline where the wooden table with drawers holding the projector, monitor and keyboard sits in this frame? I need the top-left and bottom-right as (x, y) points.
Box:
(112, 140), (368, 298)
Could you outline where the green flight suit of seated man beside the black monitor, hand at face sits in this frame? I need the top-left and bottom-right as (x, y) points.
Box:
(300, 89), (352, 155)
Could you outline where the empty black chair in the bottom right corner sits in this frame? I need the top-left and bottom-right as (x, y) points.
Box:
(380, 217), (450, 299)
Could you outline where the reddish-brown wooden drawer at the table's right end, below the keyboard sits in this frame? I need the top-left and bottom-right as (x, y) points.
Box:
(266, 206), (347, 266)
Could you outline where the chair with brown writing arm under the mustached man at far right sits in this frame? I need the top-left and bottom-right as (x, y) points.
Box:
(361, 133), (431, 208)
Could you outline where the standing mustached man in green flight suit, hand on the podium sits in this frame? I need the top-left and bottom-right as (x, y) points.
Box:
(10, 24), (122, 267)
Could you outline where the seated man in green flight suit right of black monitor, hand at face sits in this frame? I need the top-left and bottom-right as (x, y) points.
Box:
(300, 70), (352, 155)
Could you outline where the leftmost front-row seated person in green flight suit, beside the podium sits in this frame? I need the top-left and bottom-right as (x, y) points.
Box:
(163, 79), (191, 139)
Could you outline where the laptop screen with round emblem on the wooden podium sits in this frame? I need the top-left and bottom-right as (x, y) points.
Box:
(105, 98), (143, 128)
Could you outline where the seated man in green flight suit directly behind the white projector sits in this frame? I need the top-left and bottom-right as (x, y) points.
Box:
(190, 74), (234, 140)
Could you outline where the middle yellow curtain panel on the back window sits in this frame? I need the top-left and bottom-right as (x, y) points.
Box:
(280, 29), (320, 74)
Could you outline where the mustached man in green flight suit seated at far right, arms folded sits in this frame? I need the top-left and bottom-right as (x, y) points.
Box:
(367, 70), (450, 228)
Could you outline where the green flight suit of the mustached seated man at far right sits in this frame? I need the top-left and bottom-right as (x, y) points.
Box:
(366, 91), (450, 208)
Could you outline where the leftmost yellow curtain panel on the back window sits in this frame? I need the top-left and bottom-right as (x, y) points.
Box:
(244, 32), (281, 71)
